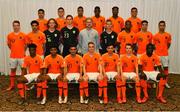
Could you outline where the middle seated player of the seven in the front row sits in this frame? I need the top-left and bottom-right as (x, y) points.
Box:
(83, 42), (103, 103)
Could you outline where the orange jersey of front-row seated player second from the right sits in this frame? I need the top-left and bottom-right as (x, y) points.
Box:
(120, 54), (138, 72)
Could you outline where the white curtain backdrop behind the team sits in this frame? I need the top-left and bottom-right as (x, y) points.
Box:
(0, 0), (180, 74)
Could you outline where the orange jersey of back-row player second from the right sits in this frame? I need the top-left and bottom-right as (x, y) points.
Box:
(109, 17), (124, 34)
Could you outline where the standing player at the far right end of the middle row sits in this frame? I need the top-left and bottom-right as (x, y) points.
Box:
(153, 21), (171, 88)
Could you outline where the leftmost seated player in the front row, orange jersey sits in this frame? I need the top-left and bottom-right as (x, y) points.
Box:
(17, 44), (43, 104)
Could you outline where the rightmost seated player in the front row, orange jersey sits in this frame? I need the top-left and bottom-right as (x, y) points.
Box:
(139, 44), (167, 103)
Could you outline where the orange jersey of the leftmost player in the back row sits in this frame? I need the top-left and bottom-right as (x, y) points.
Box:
(37, 19), (48, 32)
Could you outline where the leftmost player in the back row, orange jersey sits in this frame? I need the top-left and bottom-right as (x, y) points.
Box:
(36, 9), (47, 32)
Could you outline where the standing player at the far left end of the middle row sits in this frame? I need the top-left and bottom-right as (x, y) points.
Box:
(7, 20), (26, 90)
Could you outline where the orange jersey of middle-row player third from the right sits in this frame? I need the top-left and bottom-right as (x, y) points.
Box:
(117, 31), (136, 54)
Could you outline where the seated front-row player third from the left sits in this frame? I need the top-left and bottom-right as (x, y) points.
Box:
(63, 44), (83, 103)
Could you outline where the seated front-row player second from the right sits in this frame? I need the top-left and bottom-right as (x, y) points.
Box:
(120, 43), (141, 103)
